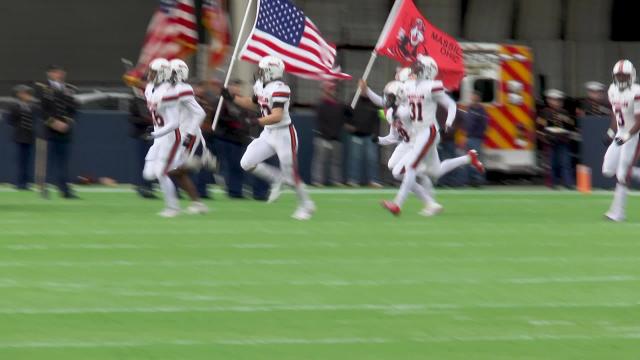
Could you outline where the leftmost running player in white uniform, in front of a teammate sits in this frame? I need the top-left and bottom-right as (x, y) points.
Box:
(142, 58), (182, 217)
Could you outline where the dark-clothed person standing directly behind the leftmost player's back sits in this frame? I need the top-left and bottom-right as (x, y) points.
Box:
(129, 96), (156, 199)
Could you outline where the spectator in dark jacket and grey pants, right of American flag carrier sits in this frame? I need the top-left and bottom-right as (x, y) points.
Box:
(312, 82), (347, 186)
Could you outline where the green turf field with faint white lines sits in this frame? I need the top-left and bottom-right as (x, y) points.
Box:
(0, 189), (640, 360)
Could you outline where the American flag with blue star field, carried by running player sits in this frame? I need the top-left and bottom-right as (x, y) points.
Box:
(240, 0), (351, 80)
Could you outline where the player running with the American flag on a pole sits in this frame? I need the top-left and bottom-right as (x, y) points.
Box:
(222, 56), (316, 220)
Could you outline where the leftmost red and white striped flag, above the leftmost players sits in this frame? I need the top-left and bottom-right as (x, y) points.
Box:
(124, 0), (198, 87)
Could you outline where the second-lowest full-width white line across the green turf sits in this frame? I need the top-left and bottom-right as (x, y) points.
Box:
(0, 302), (640, 315)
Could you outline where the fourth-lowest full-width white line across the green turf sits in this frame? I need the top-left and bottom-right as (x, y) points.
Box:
(0, 256), (640, 268)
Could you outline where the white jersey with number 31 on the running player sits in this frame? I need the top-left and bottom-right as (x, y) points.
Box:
(405, 80), (444, 130)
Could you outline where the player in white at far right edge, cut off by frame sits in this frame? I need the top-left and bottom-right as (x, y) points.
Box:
(602, 60), (640, 221)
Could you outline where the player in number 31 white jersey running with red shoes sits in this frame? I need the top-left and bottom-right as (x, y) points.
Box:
(382, 55), (484, 215)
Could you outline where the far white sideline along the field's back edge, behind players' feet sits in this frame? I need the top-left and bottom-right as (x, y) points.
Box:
(0, 186), (640, 196)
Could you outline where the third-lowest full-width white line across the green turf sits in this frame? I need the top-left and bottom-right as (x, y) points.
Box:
(0, 275), (640, 290)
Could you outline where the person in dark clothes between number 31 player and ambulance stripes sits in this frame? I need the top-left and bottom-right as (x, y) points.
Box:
(463, 91), (489, 186)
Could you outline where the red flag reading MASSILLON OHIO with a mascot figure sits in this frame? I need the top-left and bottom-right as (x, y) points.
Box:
(376, 0), (464, 90)
